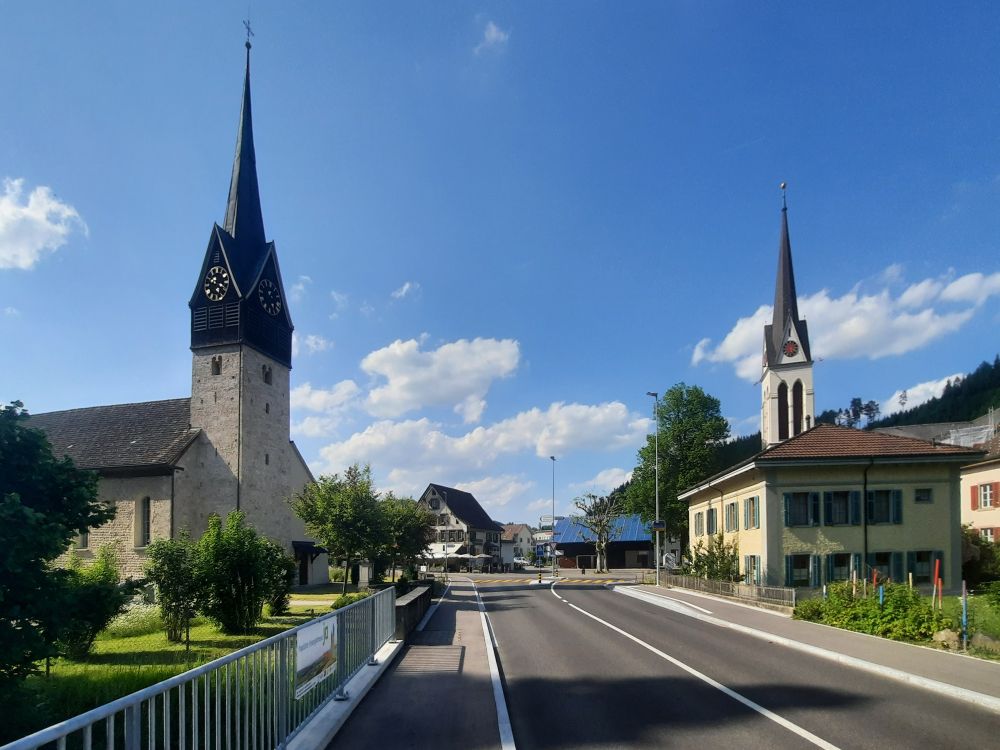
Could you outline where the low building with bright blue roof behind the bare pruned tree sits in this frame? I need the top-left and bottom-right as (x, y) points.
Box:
(554, 515), (656, 568)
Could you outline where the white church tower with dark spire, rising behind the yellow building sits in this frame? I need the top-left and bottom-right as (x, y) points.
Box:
(760, 192), (816, 448)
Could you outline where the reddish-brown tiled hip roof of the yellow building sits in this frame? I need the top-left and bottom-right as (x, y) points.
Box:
(754, 424), (982, 462)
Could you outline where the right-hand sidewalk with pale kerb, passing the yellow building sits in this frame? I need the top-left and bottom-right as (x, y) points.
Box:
(629, 586), (1000, 710)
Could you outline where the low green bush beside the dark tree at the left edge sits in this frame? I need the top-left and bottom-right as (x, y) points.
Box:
(57, 545), (141, 659)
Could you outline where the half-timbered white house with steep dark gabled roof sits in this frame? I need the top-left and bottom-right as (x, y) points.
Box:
(419, 484), (503, 565)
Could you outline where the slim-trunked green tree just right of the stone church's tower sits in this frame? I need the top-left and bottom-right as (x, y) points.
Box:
(291, 464), (386, 594)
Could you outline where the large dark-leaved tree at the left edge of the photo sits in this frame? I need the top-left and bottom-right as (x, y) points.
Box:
(0, 401), (115, 692)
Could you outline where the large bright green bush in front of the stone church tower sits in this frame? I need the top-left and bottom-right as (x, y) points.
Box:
(195, 510), (284, 633)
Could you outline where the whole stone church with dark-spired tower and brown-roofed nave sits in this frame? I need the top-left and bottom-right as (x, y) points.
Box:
(28, 42), (328, 584)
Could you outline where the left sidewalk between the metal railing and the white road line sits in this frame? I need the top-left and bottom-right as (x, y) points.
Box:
(327, 582), (500, 750)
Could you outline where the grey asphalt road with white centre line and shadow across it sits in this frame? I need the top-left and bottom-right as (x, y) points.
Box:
(478, 580), (1000, 750)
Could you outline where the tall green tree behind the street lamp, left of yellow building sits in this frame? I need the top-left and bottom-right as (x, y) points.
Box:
(626, 383), (729, 542)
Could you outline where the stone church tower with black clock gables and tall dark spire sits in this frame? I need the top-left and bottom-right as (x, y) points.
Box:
(188, 40), (301, 524)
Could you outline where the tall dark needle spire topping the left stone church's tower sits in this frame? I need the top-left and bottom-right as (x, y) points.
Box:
(223, 38), (265, 246)
